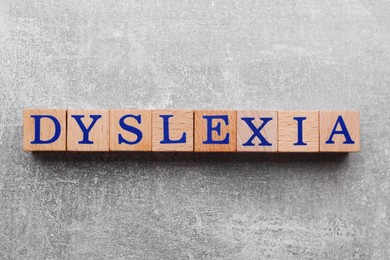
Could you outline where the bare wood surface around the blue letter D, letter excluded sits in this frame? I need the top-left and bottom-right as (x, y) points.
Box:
(23, 109), (66, 151)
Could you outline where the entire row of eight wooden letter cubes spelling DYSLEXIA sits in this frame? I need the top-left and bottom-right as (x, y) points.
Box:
(23, 109), (360, 152)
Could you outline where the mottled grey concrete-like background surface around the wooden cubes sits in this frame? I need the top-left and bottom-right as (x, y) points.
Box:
(0, 0), (390, 259)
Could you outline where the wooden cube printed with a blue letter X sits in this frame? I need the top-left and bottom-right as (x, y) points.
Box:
(237, 110), (278, 152)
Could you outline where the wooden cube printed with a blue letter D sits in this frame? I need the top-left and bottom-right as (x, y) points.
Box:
(23, 109), (66, 151)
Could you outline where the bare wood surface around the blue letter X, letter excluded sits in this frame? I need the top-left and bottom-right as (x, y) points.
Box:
(237, 110), (278, 152)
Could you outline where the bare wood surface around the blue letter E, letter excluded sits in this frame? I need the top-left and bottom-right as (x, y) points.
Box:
(194, 110), (237, 152)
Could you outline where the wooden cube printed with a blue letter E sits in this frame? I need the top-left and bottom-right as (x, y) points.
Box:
(195, 110), (237, 152)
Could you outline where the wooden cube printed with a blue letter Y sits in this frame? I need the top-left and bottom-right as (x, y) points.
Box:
(67, 109), (110, 152)
